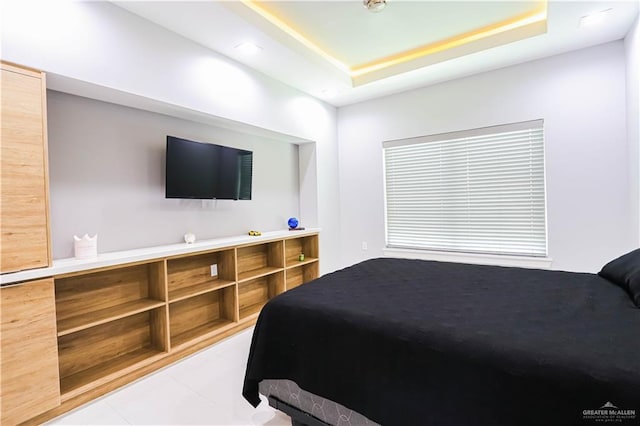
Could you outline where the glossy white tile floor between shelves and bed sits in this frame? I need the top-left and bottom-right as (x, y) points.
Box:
(47, 328), (291, 426)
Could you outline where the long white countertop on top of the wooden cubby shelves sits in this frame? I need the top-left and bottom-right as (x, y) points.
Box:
(0, 228), (320, 285)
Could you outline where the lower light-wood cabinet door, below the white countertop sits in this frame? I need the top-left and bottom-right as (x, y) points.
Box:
(0, 278), (60, 425)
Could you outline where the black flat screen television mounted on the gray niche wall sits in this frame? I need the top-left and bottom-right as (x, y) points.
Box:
(165, 136), (253, 200)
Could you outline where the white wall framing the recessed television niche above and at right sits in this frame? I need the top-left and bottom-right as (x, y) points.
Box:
(2, 0), (342, 272)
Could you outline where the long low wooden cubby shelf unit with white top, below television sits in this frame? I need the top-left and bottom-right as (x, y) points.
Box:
(5, 230), (320, 423)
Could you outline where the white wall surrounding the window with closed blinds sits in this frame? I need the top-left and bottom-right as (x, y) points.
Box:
(338, 41), (635, 271)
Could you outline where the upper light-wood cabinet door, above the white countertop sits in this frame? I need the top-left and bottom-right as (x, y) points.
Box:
(0, 63), (50, 273)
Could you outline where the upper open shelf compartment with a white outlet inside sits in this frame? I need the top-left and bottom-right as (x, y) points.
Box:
(167, 249), (236, 302)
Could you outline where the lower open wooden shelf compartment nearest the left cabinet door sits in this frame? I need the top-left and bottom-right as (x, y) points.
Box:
(58, 306), (168, 400)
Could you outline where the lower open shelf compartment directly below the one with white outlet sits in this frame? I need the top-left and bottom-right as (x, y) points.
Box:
(169, 285), (238, 349)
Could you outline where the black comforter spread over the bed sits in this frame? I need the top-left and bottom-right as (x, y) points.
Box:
(243, 258), (640, 426)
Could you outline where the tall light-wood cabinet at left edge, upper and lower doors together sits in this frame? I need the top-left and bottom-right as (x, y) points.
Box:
(0, 62), (60, 425)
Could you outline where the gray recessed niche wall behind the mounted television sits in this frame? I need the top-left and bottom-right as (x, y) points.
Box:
(48, 90), (300, 259)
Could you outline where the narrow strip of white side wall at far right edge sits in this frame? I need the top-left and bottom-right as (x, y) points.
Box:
(624, 15), (640, 247)
